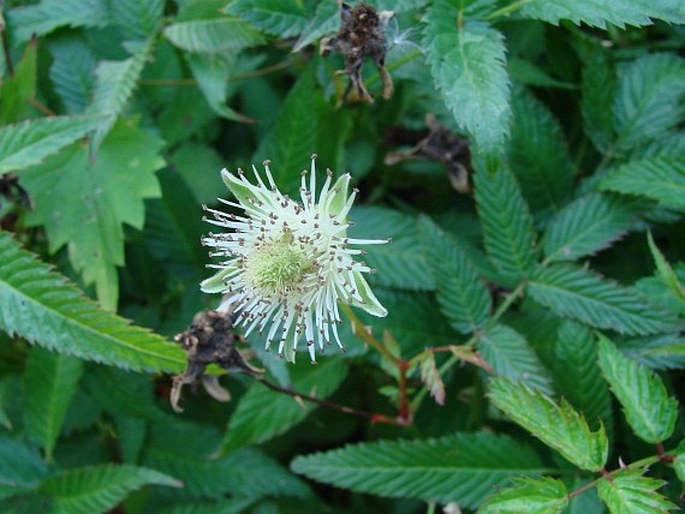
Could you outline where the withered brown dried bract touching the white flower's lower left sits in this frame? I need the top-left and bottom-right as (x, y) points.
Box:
(169, 311), (264, 412)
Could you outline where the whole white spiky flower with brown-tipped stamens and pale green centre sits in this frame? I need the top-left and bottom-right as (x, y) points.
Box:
(200, 155), (389, 361)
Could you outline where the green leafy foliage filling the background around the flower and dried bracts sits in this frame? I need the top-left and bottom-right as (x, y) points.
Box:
(0, 0), (685, 514)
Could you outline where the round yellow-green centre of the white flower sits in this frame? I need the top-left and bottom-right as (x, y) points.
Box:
(245, 234), (309, 295)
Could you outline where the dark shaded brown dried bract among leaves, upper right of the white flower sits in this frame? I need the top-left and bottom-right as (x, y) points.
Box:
(384, 114), (471, 193)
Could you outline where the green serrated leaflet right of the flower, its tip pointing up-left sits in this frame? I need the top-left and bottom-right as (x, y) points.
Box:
(414, 217), (492, 334)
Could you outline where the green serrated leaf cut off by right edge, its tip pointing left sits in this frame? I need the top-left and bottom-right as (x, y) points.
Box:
(599, 157), (685, 211)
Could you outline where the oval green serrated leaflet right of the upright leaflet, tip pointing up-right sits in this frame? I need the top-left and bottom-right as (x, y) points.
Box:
(542, 193), (643, 262)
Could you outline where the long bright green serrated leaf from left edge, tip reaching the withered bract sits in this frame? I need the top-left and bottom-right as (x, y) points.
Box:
(0, 232), (185, 373)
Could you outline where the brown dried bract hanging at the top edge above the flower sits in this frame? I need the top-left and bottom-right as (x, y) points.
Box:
(320, 0), (395, 102)
